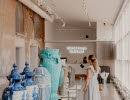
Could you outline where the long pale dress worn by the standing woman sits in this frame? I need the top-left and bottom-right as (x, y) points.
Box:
(84, 66), (101, 100)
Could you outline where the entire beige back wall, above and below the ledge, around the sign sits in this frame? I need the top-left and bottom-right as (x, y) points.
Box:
(45, 21), (96, 64)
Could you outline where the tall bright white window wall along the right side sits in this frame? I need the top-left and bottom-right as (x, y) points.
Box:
(114, 3), (130, 90)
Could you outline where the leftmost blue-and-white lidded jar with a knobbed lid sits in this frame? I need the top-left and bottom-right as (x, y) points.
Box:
(2, 64), (28, 100)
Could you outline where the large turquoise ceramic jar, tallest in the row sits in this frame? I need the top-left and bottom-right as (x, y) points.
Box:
(40, 49), (61, 100)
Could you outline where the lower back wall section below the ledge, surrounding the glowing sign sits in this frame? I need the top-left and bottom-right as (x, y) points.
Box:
(45, 43), (96, 64)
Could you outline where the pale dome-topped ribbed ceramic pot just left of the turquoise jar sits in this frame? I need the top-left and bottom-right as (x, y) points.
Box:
(34, 65), (51, 100)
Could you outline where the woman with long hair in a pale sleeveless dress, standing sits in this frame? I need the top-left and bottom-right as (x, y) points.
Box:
(83, 55), (101, 100)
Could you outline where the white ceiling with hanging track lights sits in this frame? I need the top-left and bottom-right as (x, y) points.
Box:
(38, 0), (124, 24)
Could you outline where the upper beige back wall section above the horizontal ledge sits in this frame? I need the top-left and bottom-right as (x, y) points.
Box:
(45, 21), (96, 41)
